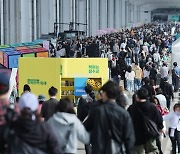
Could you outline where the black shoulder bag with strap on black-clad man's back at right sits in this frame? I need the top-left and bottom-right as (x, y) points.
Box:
(137, 106), (160, 139)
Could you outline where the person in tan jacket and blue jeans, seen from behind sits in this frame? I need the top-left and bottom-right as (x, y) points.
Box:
(133, 63), (142, 91)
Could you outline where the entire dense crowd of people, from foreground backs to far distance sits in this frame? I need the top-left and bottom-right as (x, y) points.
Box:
(0, 24), (180, 154)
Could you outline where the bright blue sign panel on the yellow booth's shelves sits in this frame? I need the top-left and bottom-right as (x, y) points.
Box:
(74, 78), (88, 96)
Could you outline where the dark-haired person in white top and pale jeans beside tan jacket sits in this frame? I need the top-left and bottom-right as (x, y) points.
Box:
(125, 66), (135, 94)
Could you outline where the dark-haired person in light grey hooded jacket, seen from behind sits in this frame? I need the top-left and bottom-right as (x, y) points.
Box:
(47, 98), (90, 154)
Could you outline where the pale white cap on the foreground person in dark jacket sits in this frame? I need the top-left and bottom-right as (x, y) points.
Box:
(19, 92), (39, 112)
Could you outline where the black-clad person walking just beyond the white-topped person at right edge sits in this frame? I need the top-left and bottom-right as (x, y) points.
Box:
(162, 77), (174, 109)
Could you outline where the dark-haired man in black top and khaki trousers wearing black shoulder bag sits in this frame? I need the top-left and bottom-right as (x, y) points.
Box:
(128, 88), (163, 154)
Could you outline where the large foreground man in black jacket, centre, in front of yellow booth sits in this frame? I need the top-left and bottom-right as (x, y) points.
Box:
(84, 81), (135, 154)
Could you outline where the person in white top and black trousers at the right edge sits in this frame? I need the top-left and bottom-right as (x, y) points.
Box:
(163, 103), (180, 154)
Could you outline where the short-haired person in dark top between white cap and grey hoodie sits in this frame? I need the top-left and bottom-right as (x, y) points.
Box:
(41, 87), (58, 121)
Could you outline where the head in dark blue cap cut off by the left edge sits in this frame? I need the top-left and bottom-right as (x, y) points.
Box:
(0, 73), (9, 95)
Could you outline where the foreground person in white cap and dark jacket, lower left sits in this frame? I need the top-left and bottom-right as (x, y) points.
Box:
(5, 92), (62, 154)
